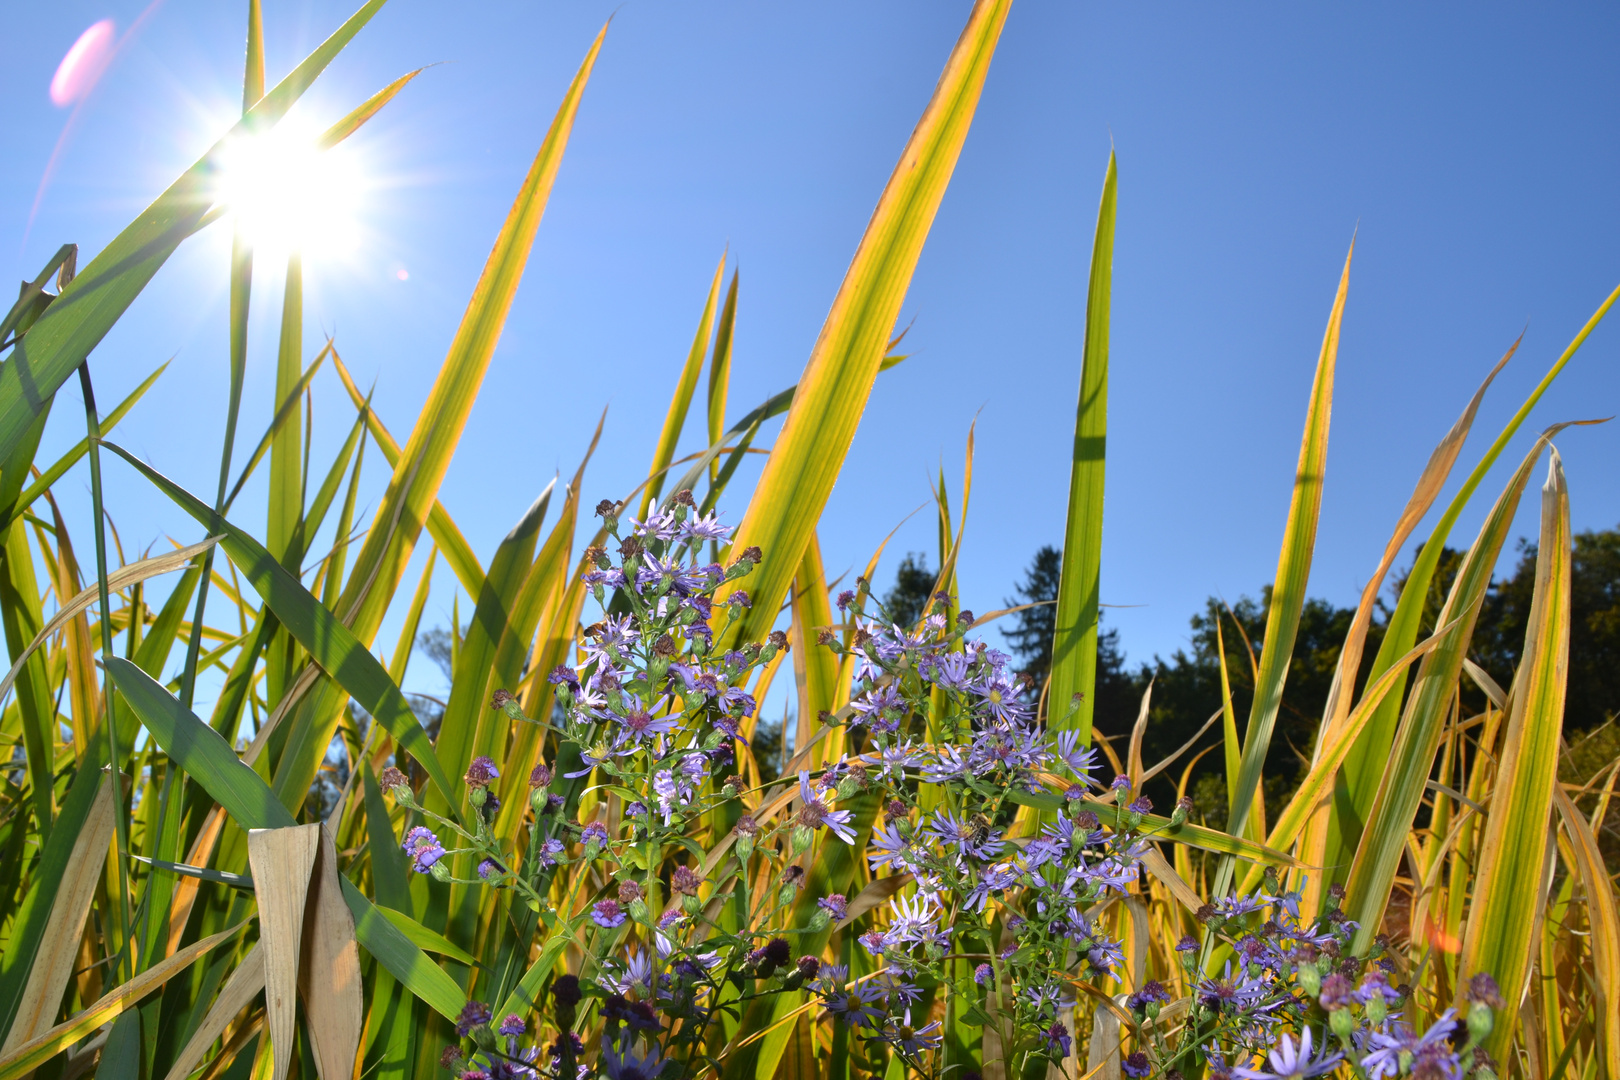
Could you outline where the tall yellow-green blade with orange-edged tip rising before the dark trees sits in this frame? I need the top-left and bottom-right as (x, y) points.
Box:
(1215, 241), (1356, 854)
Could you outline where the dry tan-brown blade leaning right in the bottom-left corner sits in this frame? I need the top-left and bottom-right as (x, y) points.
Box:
(0, 767), (113, 1057)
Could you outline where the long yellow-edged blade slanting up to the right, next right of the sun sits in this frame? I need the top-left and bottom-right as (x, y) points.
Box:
(325, 26), (608, 641)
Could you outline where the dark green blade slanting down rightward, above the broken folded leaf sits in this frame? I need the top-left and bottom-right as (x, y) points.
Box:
(105, 442), (452, 801)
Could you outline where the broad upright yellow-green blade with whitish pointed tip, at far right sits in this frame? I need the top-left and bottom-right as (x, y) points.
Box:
(1461, 447), (1573, 1059)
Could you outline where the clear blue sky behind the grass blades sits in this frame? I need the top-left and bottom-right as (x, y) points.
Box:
(0, 0), (1620, 702)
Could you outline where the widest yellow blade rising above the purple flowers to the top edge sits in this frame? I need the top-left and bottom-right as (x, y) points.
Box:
(716, 0), (1011, 647)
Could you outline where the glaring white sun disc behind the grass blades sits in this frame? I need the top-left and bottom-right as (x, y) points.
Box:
(214, 117), (363, 257)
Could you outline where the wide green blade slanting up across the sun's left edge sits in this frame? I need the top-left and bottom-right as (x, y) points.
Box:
(0, 0), (386, 460)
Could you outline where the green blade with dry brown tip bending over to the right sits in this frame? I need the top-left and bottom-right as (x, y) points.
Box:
(1343, 424), (1587, 950)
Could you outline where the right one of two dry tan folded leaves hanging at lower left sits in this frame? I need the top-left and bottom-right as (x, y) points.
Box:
(299, 827), (365, 1080)
